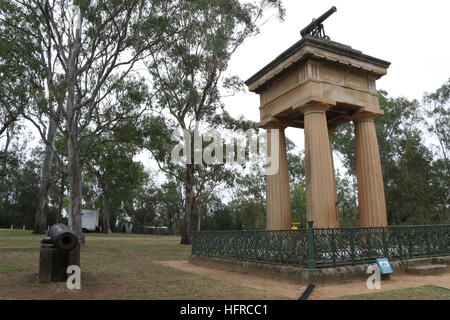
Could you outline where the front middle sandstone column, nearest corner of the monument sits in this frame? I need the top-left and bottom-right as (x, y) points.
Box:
(303, 103), (339, 228)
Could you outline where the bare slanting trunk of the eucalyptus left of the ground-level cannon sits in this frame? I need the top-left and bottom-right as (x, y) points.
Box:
(33, 117), (57, 234)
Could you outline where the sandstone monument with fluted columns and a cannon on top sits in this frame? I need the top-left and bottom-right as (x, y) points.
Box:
(245, 7), (390, 230)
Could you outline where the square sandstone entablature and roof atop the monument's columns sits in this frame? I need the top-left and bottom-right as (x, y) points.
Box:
(245, 36), (390, 128)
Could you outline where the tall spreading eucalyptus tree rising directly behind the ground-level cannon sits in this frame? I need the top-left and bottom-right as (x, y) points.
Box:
(2, 0), (171, 238)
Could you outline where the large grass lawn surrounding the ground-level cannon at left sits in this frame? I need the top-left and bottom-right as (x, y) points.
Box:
(0, 229), (283, 300)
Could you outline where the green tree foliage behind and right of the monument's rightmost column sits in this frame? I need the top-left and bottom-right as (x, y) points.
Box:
(333, 83), (450, 225)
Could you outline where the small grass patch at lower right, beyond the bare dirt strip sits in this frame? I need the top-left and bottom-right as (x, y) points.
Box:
(339, 285), (450, 300)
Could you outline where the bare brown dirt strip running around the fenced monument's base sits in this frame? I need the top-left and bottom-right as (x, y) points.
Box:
(160, 260), (450, 300)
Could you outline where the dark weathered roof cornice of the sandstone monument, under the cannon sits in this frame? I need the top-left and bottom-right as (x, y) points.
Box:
(245, 36), (391, 91)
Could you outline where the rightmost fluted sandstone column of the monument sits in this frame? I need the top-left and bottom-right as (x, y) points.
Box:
(354, 115), (387, 227)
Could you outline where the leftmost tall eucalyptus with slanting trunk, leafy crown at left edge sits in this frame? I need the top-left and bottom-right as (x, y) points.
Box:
(0, 1), (63, 233)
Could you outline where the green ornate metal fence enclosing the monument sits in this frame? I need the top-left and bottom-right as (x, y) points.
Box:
(192, 225), (450, 268)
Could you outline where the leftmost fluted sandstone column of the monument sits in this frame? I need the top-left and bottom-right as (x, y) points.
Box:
(266, 127), (291, 230)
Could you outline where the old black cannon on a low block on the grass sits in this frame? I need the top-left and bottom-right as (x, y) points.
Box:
(39, 223), (80, 282)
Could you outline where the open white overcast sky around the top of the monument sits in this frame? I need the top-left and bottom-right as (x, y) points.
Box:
(221, 0), (450, 155)
